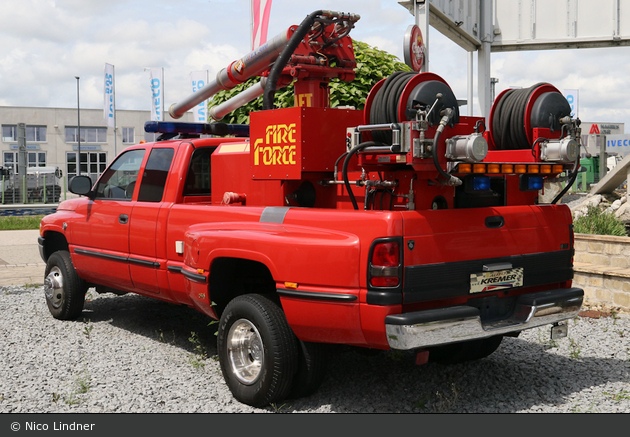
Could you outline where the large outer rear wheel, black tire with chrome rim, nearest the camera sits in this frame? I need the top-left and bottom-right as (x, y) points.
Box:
(217, 294), (298, 407)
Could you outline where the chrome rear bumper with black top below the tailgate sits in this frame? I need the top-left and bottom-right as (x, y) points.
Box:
(385, 288), (584, 350)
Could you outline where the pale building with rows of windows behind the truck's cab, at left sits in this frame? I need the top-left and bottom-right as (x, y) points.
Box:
(0, 106), (193, 181)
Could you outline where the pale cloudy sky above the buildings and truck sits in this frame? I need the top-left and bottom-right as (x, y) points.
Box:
(0, 0), (630, 126)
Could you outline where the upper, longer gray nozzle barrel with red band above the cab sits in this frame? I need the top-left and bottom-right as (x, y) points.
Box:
(168, 30), (289, 119)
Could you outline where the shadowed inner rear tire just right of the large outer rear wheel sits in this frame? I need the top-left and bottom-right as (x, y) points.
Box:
(289, 340), (328, 399)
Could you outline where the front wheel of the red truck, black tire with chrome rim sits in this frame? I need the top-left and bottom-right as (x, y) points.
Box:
(44, 250), (88, 320)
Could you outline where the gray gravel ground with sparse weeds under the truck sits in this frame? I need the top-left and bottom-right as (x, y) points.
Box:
(0, 287), (630, 413)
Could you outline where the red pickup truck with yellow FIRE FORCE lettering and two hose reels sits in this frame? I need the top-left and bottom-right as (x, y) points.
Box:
(39, 10), (584, 406)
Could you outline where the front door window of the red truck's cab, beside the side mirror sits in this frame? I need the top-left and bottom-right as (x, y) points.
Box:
(95, 149), (145, 200)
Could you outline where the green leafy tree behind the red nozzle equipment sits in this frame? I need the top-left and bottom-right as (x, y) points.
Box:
(208, 40), (411, 124)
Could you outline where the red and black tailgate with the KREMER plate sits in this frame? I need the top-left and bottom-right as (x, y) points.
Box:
(403, 205), (573, 303)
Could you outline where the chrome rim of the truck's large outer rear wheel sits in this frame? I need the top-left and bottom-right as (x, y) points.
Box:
(227, 319), (265, 385)
